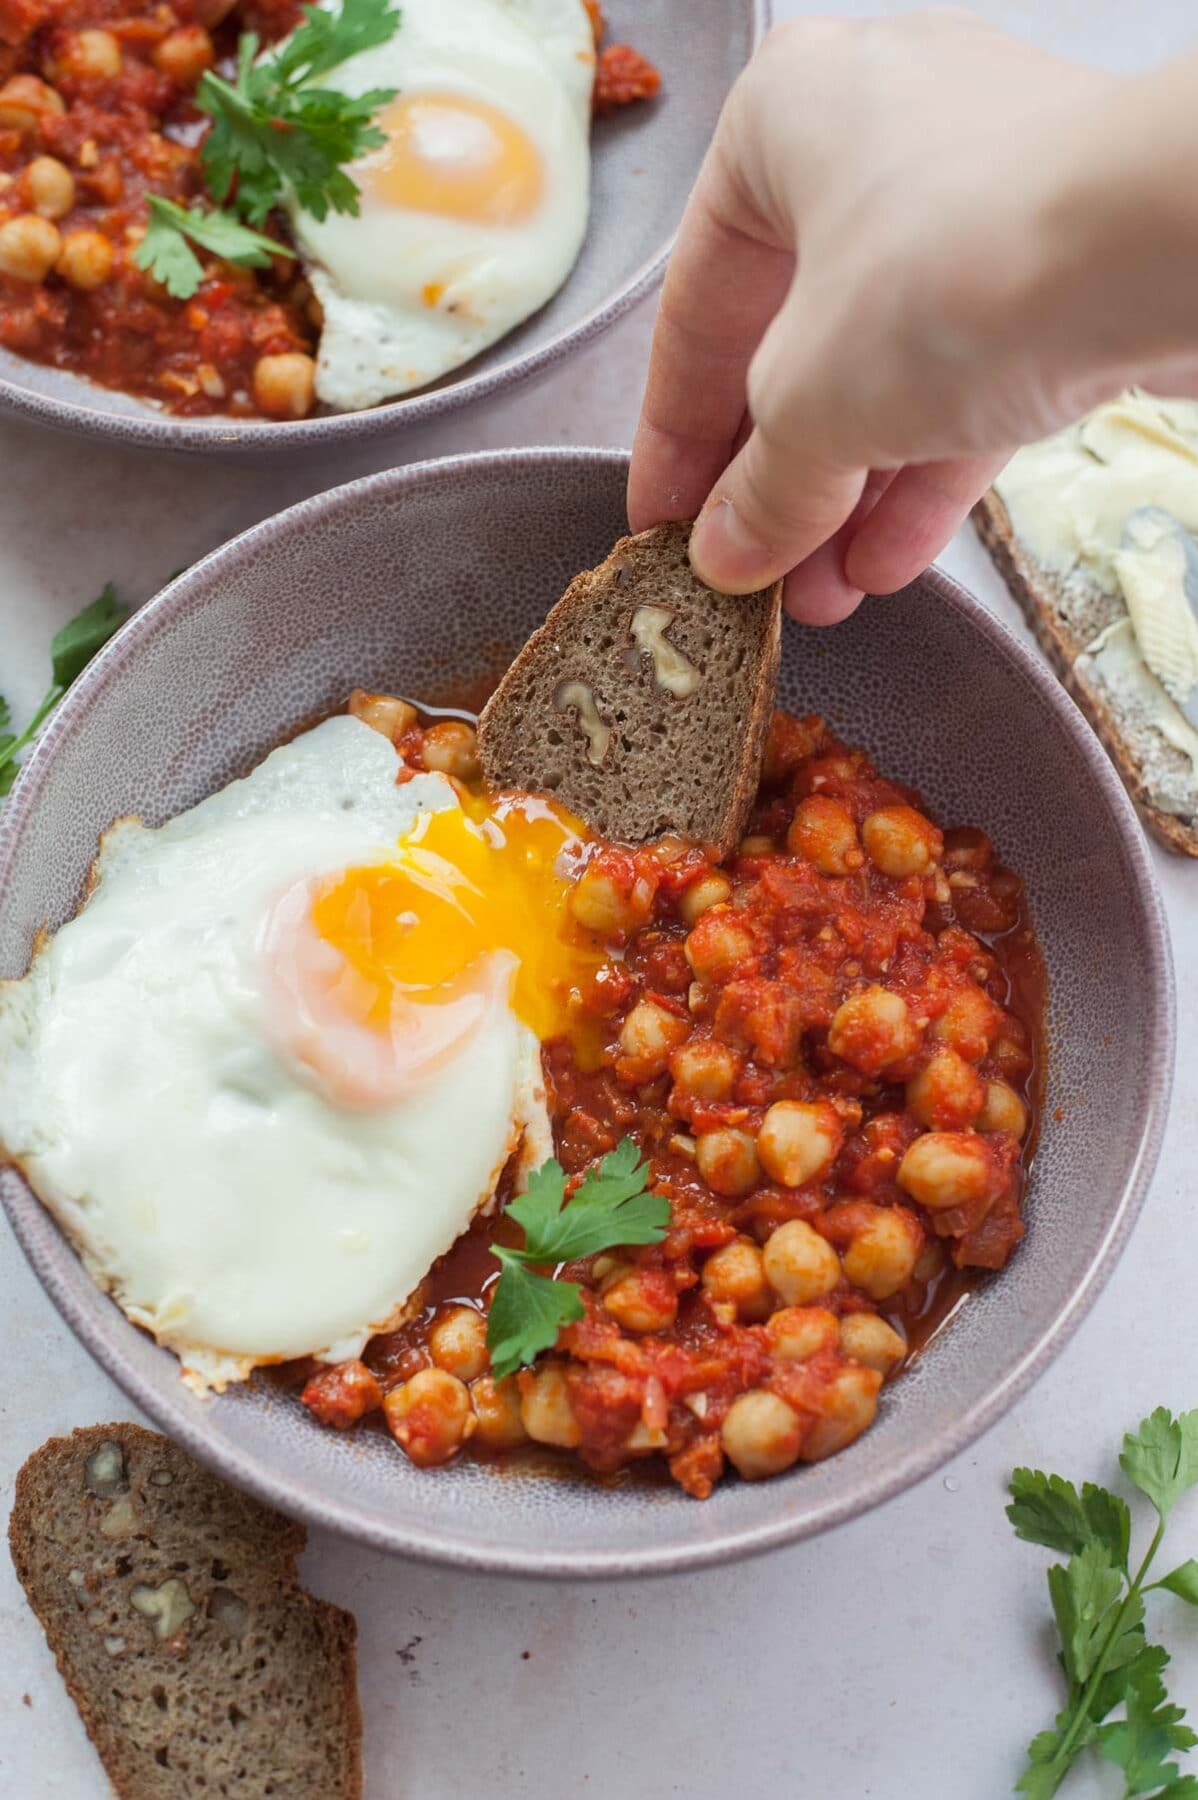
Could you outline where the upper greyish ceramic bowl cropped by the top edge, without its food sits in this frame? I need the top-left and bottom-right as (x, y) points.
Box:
(0, 0), (770, 459)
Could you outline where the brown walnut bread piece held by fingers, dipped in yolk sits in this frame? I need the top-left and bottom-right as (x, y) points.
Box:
(478, 522), (781, 853)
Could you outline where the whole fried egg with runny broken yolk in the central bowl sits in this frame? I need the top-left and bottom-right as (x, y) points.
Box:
(0, 718), (603, 1386)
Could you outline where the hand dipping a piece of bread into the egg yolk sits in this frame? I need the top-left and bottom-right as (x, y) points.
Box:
(628, 11), (1198, 623)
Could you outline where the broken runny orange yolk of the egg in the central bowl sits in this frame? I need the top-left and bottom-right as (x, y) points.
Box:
(263, 794), (606, 1107)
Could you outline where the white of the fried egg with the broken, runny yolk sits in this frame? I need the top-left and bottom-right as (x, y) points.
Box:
(0, 718), (550, 1386)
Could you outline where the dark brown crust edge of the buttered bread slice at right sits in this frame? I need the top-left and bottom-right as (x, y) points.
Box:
(973, 488), (1198, 857)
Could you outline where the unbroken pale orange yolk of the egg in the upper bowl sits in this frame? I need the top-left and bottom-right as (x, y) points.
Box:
(362, 94), (545, 225)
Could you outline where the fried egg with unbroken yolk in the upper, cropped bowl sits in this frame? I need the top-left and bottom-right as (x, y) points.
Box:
(290, 0), (595, 410)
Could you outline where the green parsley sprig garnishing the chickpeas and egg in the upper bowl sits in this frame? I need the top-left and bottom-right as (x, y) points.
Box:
(135, 0), (399, 301)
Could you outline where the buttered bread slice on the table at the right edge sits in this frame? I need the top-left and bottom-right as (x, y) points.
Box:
(973, 392), (1198, 857)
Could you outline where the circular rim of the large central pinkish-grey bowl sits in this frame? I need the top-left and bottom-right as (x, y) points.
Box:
(0, 445), (1176, 1579)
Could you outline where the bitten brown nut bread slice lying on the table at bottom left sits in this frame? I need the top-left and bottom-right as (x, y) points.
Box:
(9, 1424), (362, 1800)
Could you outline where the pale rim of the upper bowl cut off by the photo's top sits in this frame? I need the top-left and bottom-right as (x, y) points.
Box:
(0, 0), (773, 459)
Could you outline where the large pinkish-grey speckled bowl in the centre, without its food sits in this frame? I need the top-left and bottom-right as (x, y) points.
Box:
(0, 450), (1173, 1575)
